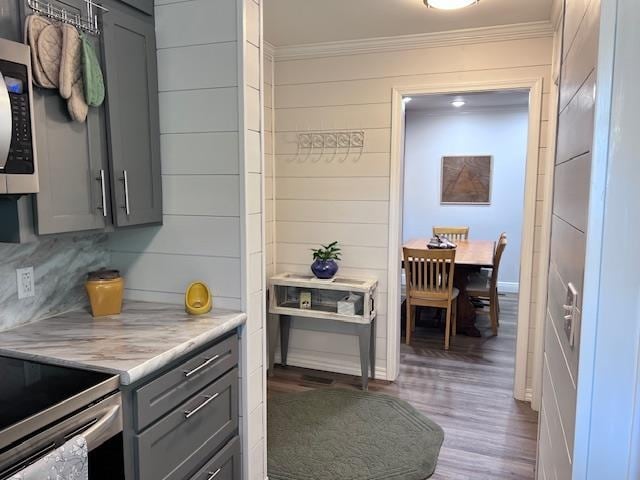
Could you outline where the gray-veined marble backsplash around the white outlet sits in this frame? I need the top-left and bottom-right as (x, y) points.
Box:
(0, 234), (110, 331)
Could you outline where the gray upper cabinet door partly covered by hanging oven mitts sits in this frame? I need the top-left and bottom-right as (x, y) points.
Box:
(23, 0), (111, 234)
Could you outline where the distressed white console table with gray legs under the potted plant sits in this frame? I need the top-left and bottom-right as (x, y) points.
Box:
(269, 273), (378, 390)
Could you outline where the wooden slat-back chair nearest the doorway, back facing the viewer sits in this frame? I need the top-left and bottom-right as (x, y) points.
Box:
(403, 248), (458, 350)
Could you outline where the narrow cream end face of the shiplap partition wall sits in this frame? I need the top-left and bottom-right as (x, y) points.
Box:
(239, 0), (267, 480)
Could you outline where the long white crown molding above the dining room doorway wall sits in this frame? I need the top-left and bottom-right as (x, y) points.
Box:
(265, 21), (554, 60)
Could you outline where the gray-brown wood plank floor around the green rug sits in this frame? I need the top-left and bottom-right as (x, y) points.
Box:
(267, 295), (538, 480)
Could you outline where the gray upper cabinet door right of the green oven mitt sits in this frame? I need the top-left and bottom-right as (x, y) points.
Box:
(102, 2), (162, 227)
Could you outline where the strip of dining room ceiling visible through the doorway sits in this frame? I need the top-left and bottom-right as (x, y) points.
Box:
(406, 90), (529, 112)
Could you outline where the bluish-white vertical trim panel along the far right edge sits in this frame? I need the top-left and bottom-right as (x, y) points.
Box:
(571, 0), (640, 480)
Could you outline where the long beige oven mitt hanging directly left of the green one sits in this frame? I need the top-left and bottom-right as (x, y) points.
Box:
(60, 25), (89, 122)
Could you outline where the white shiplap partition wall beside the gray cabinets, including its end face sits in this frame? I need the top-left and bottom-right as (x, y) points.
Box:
(109, 0), (266, 480)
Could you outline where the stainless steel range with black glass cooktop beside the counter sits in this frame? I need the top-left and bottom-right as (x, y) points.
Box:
(0, 357), (124, 480)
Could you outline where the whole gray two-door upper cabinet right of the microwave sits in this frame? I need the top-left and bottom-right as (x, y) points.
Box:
(0, 0), (162, 240)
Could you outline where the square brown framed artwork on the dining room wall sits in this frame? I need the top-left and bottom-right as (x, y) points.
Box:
(440, 155), (493, 205)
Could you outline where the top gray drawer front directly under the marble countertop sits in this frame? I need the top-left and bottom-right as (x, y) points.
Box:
(134, 335), (238, 432)
